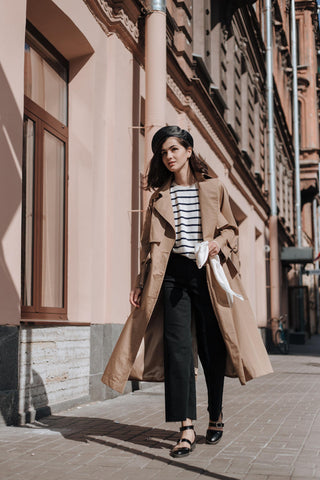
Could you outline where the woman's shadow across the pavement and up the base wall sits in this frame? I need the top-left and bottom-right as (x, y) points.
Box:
(21, 369), (237, 480)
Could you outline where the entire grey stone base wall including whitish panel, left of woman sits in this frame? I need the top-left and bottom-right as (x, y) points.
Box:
(0, 324), (265, 425)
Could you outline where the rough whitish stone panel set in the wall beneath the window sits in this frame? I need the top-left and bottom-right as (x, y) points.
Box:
(18, 325), (90, 424)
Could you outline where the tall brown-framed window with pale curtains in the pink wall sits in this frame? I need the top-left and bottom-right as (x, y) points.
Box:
(21, 25), (68, 319)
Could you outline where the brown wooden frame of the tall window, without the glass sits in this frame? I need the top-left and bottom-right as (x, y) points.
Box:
(21, 25), (69, 321)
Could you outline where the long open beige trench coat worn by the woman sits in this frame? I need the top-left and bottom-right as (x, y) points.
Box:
(102, 177), (272, 393)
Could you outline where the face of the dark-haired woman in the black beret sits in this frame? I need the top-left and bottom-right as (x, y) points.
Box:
(161, 137), (192, 174)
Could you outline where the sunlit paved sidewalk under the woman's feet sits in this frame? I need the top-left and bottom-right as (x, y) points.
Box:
(0, 336), (320, 480)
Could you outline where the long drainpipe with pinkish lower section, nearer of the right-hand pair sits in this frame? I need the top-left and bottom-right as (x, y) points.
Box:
(266, 0), (280, 324)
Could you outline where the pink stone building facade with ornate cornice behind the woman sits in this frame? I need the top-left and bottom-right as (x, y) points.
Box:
(0, 0), (318, 423)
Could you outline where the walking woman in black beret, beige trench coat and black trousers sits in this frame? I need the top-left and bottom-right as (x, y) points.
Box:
(102, 126), (272, 457)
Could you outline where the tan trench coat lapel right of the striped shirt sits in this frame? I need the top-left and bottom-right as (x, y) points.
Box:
(198, 177), (219, 241)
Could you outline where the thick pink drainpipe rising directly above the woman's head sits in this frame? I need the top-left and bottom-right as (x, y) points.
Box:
(143, 0), (167, 209)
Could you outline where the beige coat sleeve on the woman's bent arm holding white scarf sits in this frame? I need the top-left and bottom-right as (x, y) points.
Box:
(214, 184), (238, 259)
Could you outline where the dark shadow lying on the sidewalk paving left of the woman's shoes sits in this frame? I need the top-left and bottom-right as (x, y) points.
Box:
(21, 415), (238, 480)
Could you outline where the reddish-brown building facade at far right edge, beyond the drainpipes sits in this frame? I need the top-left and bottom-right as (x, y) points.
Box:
(292, 1), (320, 335)
